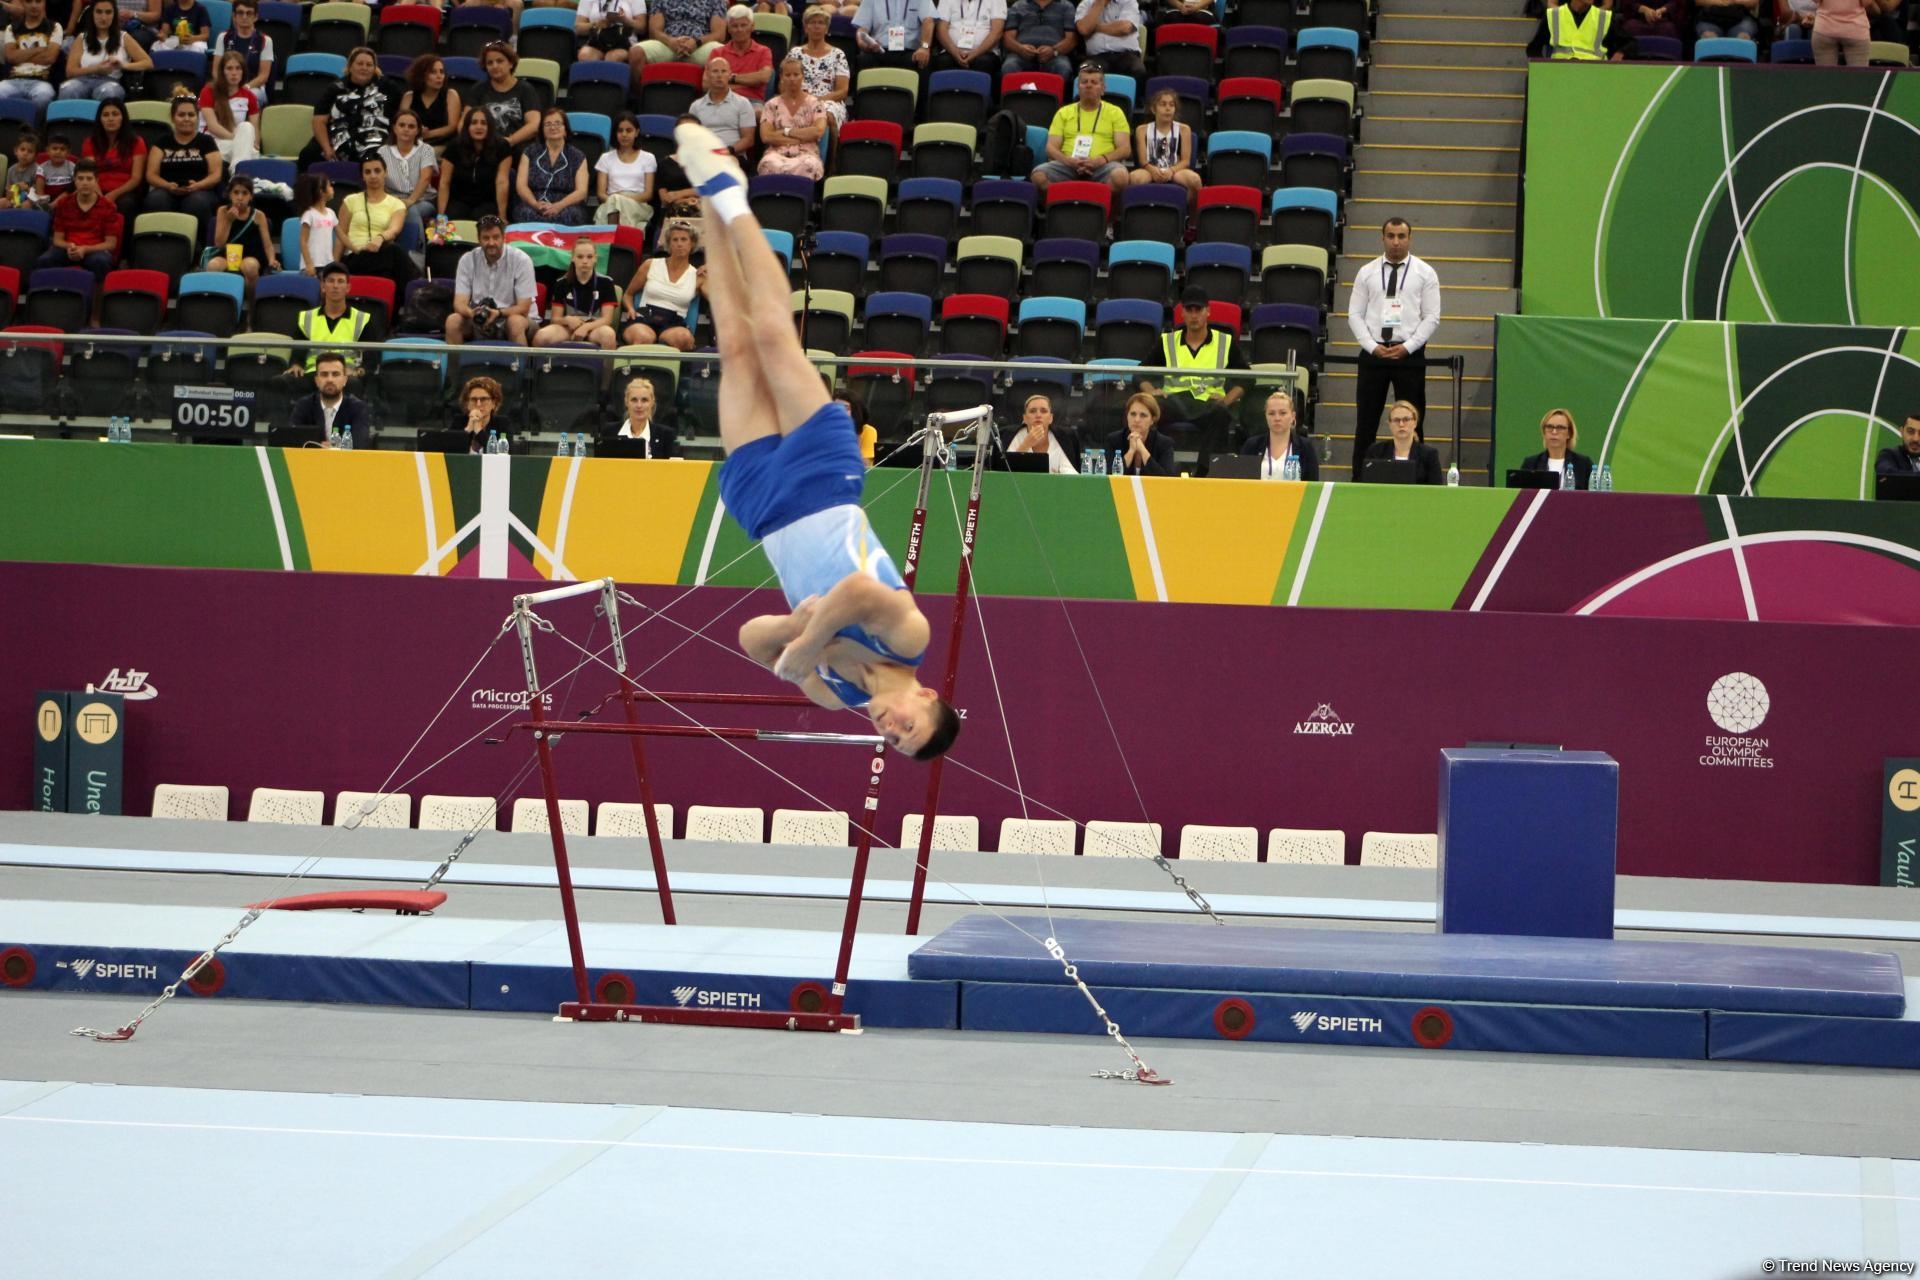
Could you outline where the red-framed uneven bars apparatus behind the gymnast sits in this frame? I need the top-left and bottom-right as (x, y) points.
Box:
(511, 405), (998, 1031)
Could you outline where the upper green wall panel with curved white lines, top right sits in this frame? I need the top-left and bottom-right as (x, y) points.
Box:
(1521, 61), (1920, 324)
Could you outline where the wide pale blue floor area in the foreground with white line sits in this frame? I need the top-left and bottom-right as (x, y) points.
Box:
(0, 1082), (1920, 1280)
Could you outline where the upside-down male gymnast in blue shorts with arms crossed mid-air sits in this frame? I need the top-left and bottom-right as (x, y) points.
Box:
(674, 125), (960, 760)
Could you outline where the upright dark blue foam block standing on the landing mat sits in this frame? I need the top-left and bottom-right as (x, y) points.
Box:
(1436, 748), (1620, 938)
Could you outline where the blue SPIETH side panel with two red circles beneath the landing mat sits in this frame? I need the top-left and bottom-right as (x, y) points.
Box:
(960, 983), (1707, 1059)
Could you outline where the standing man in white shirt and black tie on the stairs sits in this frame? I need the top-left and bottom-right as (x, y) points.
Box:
(1346, 217), (1440, 480)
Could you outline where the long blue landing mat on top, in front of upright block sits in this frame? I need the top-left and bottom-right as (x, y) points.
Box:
(908, 915), (1907, 1017)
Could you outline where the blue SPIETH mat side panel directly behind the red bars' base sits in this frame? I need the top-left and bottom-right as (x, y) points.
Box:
(472, 963), (960, 1031)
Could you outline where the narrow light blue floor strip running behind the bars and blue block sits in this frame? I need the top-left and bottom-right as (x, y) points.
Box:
(0, 844), (1920, 942)
